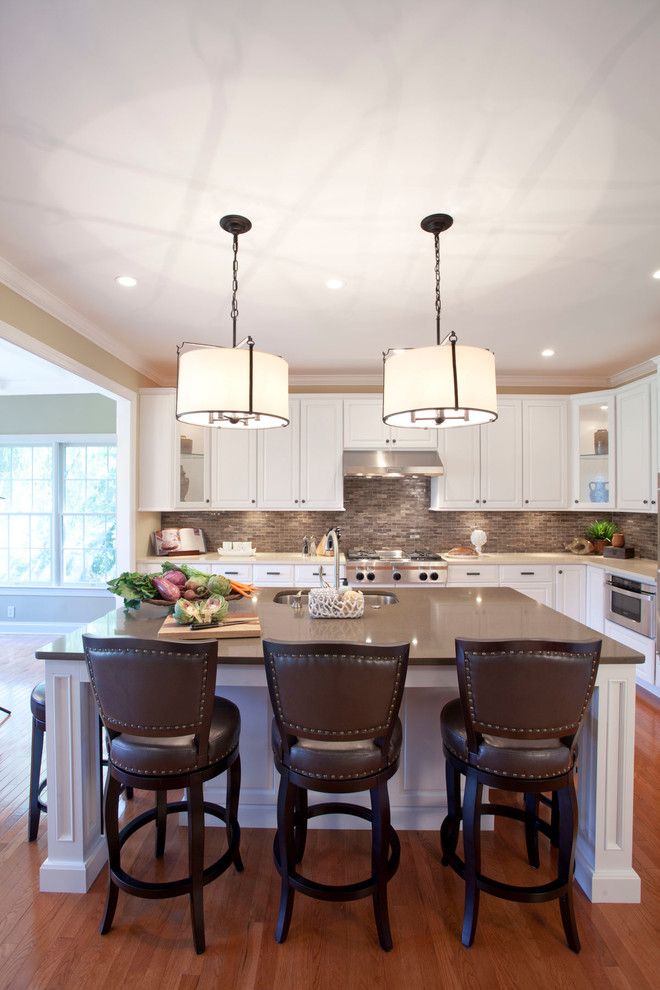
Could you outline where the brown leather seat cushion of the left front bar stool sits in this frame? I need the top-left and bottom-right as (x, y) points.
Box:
(109, 697), (241, 776)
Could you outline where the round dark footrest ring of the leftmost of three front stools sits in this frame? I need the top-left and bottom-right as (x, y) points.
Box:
(110, 801), (241, 898)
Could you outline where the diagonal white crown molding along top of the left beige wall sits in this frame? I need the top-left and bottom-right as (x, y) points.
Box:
(0, 256), (166, 384)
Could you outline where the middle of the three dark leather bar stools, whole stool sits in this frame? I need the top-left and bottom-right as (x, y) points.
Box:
(264, 640), (410, 950)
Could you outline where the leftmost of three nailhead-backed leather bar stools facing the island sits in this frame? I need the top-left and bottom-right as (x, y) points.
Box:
(83, 636), (243, 953)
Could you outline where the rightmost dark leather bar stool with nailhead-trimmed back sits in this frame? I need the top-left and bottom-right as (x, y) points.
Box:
(440, 639), (601, 952)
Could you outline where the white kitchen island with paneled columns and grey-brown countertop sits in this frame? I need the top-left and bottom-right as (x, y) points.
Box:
(36, 588), (643, 902)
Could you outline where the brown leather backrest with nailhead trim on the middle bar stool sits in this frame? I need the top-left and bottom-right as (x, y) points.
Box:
(263, 640), (410, 746)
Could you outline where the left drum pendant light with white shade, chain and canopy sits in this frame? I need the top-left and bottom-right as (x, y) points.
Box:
(176, 216), (289, 430)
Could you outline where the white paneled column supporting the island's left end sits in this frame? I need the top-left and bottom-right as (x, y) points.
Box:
(39, 659), (107, 894)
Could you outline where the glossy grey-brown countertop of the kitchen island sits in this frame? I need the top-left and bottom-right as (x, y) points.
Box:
(36, 588), (644, 665)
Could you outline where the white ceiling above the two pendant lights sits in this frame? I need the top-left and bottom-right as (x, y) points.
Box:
(0, 0), (660, 383)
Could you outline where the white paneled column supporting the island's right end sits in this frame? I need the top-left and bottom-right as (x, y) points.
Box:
(575, 664), (641, 904)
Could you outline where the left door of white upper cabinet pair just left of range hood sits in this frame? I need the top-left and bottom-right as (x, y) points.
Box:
(257, 399), (300, 509)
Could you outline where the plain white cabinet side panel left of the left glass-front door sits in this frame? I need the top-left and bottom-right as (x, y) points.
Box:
(138, 388), (176, 512)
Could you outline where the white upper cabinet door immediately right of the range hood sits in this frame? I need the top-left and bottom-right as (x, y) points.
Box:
(431, 426), (481, 509)
